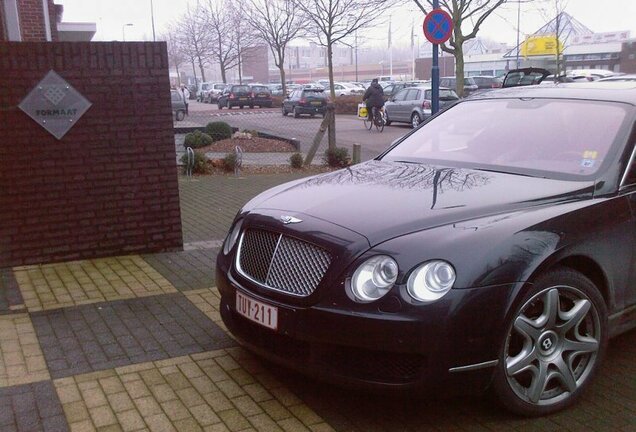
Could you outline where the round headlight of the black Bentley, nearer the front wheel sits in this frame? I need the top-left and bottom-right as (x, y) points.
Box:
(406, 260), (456, 302)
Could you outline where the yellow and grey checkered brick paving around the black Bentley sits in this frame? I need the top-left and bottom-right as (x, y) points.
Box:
(0, 174), (636, 432)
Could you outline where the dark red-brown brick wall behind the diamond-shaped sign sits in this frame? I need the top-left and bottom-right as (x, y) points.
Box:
(0, 42), (182, 268)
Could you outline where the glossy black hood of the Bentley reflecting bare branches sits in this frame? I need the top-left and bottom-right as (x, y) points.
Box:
(246, 161), (594, 245)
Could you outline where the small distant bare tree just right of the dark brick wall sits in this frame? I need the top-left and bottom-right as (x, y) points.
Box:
(175, 3), (211, 81)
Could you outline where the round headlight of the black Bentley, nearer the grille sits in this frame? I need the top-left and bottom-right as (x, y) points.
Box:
(351, 255), (398, 303)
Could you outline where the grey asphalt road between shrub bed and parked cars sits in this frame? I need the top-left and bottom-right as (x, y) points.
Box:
(175, 101), (411, 160)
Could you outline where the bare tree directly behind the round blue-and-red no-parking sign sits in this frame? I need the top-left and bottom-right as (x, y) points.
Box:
(413, 0), (507, 96)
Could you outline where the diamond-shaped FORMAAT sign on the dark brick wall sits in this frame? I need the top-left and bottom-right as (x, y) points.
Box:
(18, 71), (92, 139)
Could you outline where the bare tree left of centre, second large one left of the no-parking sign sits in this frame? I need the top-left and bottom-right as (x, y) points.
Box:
(247, 0), (306, 94)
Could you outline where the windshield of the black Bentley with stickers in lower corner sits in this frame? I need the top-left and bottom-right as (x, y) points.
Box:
(382, 99), (628, 179)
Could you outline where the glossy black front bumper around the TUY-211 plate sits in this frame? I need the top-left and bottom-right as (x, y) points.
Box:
(216, 254), (514, 391)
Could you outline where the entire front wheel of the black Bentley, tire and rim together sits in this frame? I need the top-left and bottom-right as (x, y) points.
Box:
(493, 268), (608, 417)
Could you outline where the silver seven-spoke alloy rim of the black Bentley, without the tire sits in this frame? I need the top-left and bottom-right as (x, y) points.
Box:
(504, 285), (604, 406)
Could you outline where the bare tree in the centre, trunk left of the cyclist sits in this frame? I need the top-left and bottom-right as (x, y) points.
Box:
(294, 0), (396, 99)
